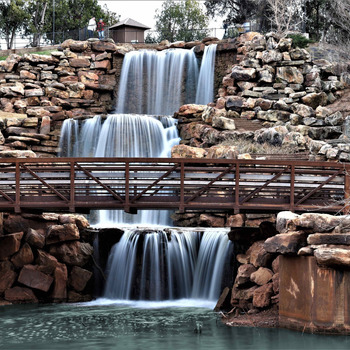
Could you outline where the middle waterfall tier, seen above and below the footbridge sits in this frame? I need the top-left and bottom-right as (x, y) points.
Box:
(59, 114), (179, 227)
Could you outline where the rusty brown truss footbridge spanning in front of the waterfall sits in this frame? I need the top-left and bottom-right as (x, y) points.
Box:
(0, 158), (350, 213)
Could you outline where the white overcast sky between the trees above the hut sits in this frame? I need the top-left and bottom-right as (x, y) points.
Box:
(98, 0), (222, 29)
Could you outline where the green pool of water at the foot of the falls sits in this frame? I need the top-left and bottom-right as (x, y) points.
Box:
(0, 300), (350, 350)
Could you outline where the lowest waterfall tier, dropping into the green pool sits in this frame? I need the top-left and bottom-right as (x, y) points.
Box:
(104, 229), (233, 301)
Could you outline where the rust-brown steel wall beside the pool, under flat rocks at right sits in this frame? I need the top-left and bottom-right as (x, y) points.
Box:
(279, 256), (350, 334)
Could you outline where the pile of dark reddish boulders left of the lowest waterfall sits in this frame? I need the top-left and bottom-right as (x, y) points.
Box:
(0, 214), (93, 303)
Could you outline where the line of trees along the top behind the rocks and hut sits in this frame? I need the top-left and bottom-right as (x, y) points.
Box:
(0, 0), (350, 48)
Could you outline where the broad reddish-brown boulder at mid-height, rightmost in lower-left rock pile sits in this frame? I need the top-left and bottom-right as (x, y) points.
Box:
(49, 241), (93, 267)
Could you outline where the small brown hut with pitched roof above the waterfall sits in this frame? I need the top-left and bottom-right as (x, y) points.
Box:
(109, 18), (151, 43)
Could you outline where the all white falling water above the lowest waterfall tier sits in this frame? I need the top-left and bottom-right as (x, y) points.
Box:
(59, 45), (216, 227)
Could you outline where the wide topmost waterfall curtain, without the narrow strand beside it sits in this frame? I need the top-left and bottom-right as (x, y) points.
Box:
(116, 49), (198, 115)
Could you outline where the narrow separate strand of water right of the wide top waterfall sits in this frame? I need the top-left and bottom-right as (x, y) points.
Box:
(196, 44), (217, 105)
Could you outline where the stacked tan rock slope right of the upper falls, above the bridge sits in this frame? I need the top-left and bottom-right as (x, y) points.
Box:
(175, 33), (350, 161)
